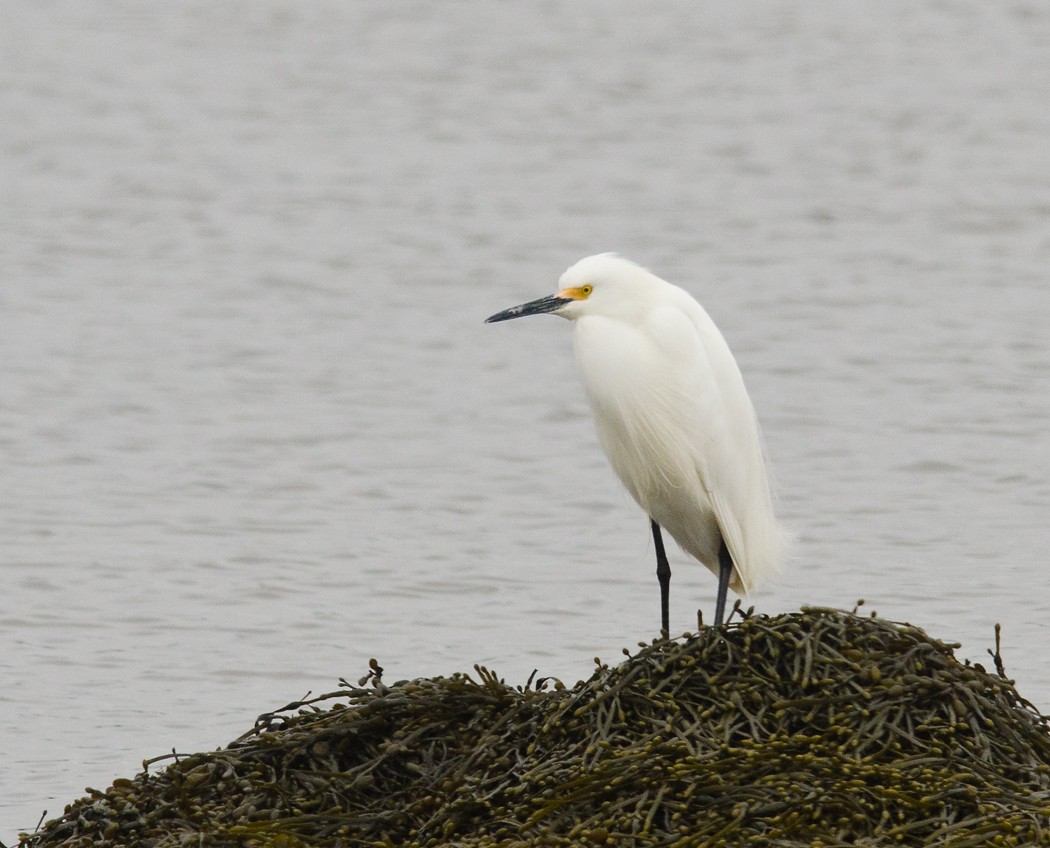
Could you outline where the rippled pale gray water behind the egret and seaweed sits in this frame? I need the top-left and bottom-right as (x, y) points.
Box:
(0, 0), (1050, 841)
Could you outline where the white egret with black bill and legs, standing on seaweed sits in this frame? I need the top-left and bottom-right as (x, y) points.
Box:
(486, 253), (784, 632)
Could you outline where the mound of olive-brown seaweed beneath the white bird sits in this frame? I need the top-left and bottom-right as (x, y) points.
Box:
(21, 609), (1050, 848)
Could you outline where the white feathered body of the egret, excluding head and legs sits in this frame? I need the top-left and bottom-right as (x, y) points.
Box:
(574, 300), (777, 592)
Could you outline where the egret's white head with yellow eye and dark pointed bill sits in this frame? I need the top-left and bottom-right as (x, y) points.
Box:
(485, 253), (657, 323)
